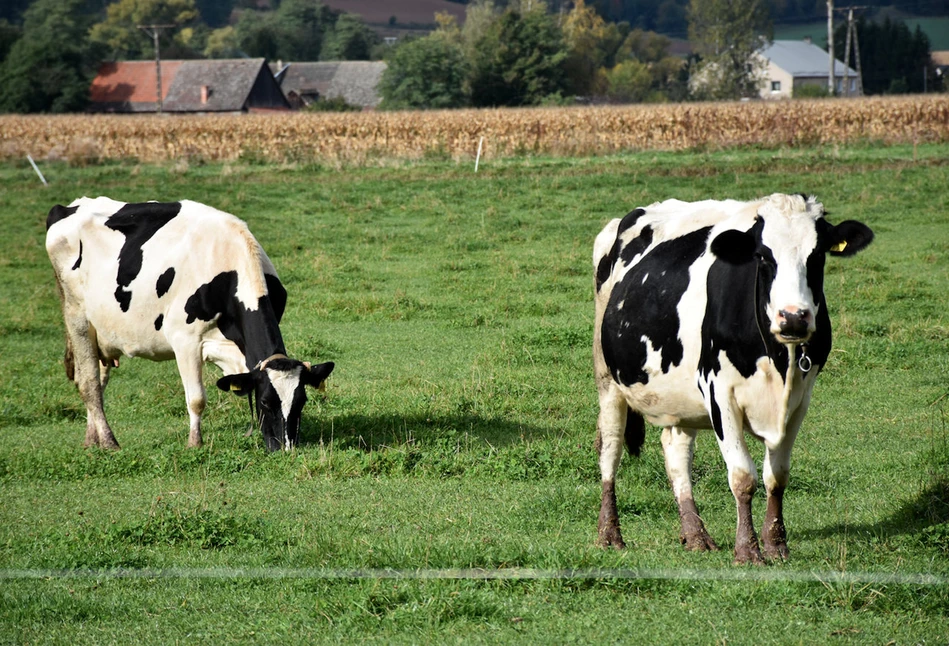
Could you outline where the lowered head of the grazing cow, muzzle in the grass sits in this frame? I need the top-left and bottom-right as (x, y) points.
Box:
(217, 355), (334, 451)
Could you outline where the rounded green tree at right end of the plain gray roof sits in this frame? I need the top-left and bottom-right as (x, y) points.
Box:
(379, 32), (468, 110)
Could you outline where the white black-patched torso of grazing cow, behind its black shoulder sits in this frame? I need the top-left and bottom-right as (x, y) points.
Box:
(46, 197), (276, 359)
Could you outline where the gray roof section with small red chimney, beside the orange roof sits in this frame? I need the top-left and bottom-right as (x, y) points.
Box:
(164, 58), (289, 112)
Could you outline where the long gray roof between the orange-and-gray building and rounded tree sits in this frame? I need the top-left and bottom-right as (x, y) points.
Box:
(271, 61), (386, 108)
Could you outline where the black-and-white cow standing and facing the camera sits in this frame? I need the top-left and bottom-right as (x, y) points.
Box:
(593, 194), (873, 563)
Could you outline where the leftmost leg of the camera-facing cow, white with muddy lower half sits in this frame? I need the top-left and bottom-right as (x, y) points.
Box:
(596, 387), (628, 550)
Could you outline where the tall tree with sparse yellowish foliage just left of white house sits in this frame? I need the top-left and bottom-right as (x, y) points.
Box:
(689, 0), (774, 99)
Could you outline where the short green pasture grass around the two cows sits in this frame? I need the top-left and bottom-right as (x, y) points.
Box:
(0, 146), (949, 644)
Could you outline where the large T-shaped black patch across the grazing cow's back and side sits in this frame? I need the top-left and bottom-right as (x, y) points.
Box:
(105, 202), (181, 312)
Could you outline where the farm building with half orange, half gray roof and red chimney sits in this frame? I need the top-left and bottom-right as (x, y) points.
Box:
(90, 58), (290, 113)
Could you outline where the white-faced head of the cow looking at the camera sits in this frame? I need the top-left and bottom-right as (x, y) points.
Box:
(711, 194), (873, 344)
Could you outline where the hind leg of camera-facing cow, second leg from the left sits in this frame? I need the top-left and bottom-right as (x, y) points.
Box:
(662, 426), (718, 552)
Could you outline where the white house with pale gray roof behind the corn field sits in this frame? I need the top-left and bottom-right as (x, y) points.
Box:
(759, 39), (860, 99)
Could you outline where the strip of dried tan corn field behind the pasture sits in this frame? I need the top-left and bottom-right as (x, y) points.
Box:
(0, 95), (949, 165)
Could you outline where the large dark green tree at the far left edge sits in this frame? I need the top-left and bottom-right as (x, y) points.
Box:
(0, 0), (98, 112)
